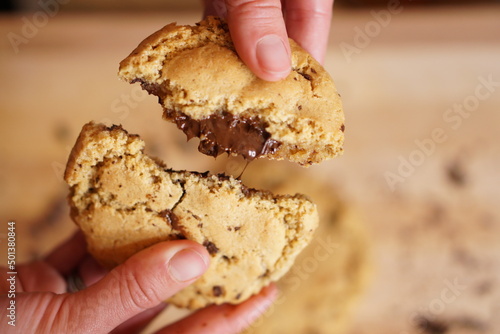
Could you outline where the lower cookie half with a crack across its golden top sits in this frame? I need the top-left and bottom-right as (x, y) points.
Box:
(65, 123), (318, 309)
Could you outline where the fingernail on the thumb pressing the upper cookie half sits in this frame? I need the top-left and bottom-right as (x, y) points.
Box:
(257, 35), (291, 76)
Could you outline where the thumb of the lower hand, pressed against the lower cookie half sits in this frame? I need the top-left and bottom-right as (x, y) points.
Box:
(60, 240), (210, 333)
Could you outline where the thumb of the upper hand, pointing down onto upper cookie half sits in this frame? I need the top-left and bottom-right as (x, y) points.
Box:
(226, 0), (291, 81)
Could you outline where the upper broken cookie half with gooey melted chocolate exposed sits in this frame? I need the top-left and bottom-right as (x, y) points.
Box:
(119, 17), (344, 166)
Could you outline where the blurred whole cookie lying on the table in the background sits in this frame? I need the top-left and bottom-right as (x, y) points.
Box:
(232, 160), (370, 334)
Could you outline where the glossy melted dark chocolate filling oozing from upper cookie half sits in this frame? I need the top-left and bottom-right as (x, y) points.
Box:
(136, 80), (281, 160)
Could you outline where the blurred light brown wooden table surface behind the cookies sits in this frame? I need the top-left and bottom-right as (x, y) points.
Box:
(0, 6), (500, 334)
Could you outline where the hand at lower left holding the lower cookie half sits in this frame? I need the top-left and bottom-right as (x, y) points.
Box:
(0, 233), (276, 334)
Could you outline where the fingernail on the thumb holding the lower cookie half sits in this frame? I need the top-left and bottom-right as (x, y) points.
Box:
(168, 248), (208, 282)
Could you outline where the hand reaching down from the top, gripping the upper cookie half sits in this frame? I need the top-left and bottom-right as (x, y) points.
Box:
(204, 0), (333, 81)
